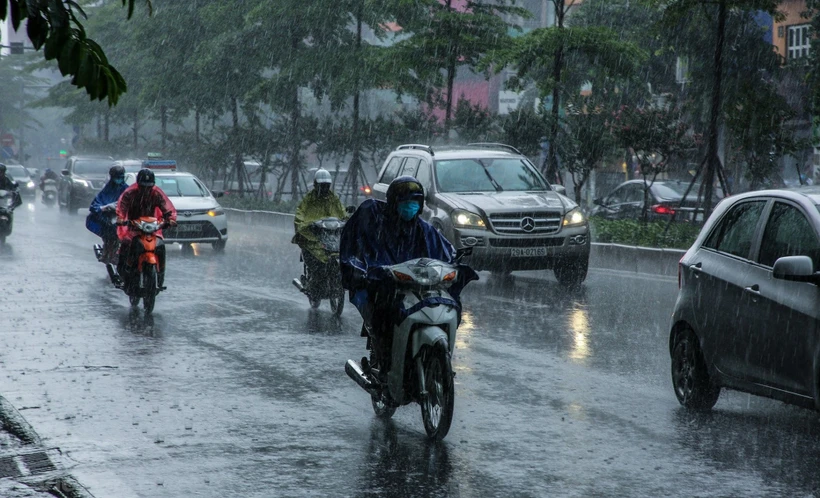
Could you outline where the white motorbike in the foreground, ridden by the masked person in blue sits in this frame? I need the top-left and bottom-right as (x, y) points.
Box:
(345, 251), (478, 440)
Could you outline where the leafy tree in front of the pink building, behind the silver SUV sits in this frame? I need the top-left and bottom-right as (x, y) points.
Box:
(395, 0), (529, 137)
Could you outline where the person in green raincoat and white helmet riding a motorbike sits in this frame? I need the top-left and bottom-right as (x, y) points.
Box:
(291, 169), (347, 271)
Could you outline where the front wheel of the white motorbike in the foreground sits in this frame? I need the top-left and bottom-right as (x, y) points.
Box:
(421, 342), (455, 441)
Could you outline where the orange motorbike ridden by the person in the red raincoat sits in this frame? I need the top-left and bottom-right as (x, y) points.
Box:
(118, 216), (166, 313)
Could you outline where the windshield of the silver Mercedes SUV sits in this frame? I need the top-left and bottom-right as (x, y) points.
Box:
(436, 158), (550, 193)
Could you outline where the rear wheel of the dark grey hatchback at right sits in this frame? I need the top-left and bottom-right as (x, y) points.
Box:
(672, 330), (720, 411)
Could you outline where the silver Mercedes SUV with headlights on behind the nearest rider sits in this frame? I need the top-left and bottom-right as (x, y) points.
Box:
(373, 144), (590, 285)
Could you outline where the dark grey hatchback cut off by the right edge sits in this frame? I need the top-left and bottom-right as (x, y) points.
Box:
(669, 187), (820, 409)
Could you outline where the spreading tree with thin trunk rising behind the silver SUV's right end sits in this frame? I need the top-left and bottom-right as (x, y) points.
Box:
(488, 14), (646, 182)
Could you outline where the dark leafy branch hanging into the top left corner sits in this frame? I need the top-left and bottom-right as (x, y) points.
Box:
(0, 0), (151, 105)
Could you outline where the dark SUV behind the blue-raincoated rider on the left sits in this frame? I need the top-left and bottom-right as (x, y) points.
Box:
(57, 156), (114, 214)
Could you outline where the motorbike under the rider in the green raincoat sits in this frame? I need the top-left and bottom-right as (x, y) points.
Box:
(293, 218), (345, 316)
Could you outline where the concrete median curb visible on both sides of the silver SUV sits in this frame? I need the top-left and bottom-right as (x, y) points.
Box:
(225, 208), (686, 276)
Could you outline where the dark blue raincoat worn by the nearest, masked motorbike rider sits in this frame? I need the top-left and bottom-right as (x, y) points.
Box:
(339, 199), (478, 318)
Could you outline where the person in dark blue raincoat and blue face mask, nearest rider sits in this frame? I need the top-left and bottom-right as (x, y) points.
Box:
(339, 176), (478, 366)
